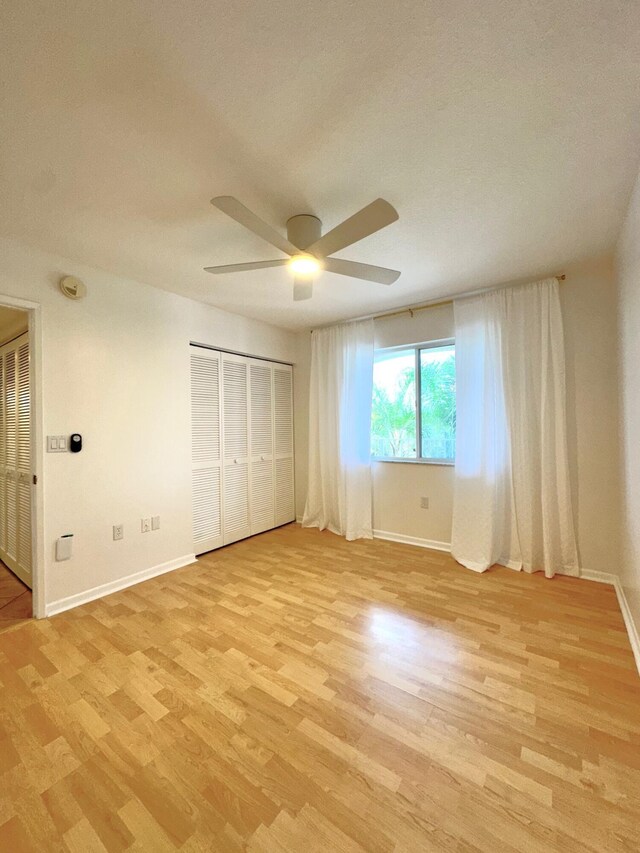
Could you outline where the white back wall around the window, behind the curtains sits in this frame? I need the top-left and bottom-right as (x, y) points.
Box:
(296, 253), (619, 572)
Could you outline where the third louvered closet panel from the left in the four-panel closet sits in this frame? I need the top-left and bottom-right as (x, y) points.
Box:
(249, 361), (275, 534)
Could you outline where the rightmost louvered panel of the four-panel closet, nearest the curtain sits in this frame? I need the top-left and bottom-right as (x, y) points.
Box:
(273, 364), (296, 525)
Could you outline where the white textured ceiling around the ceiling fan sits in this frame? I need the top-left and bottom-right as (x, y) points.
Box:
(0, 0), (640, 328)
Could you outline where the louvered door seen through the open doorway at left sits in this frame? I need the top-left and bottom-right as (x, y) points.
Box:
(0, 334), (32, 587)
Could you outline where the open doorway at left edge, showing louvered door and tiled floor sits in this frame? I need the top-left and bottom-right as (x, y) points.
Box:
(0, 297), (39, 631)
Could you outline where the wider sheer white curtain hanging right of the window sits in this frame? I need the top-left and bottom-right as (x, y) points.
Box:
(451, 279), (578, 577)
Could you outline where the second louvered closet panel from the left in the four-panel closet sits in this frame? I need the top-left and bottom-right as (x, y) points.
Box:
(222, 353), (251, 545)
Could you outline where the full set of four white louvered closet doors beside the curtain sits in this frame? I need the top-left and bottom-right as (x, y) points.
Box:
(191, 345), (295, 554)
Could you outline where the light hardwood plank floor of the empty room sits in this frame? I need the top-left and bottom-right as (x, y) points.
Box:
(0, 525), (640, 853)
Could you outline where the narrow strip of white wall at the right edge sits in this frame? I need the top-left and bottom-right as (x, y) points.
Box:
(617, 171), (640, 626)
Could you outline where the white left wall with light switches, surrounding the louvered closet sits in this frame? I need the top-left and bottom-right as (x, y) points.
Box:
(0, 241), (295, 603)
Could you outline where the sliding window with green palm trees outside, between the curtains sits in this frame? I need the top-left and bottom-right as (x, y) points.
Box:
(371, 342), (456, 462)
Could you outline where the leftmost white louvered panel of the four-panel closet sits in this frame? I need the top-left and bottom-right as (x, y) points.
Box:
(191, 347), (223, 554)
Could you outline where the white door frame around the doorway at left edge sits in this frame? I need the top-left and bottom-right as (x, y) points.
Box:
(0, 294), (46, 619)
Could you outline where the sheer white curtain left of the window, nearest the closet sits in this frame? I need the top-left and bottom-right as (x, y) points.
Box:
(302, 320), (373, 539)
